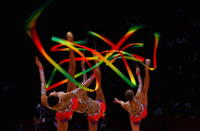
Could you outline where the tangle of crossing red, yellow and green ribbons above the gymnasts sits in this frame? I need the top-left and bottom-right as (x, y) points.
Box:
(25, 0), (160, 92)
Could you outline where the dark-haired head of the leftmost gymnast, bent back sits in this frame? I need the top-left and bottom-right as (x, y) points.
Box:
(47, 91), (59, 107)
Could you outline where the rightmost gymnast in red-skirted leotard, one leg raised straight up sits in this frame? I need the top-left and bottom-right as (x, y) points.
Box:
(114, 59), (151, 131)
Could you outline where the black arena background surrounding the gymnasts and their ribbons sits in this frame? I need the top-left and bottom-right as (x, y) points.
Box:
(0, 0), (200, 131)
